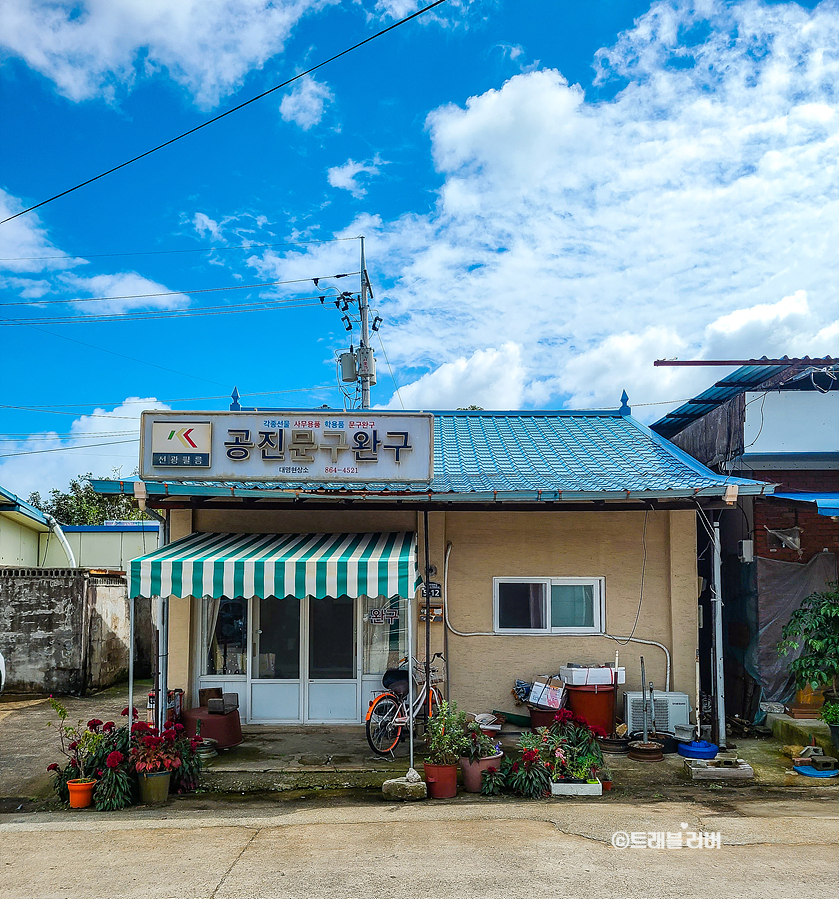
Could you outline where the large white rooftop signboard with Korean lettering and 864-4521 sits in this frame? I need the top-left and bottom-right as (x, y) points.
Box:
(140, 409), (434, 483)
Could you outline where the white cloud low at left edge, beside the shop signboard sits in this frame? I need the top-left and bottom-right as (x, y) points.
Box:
(0, 397), (169, 499)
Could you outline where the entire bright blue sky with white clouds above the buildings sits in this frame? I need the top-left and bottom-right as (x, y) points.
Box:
(0, 0), (839, 495)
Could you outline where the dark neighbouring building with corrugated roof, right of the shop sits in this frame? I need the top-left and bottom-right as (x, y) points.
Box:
(652, 360), (839, 720)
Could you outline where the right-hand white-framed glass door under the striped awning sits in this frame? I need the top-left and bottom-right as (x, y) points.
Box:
(306, 596), (361, 724)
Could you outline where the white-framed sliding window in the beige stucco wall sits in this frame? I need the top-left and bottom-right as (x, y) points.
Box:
(492, 577), (606, 635)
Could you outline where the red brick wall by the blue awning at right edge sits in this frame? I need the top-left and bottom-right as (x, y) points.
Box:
(753, 471), (839, 562)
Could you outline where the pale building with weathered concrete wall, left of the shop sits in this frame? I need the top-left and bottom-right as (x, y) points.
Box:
(0, 488), (159, 693)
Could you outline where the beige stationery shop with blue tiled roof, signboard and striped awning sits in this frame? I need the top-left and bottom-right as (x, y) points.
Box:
(94, 404), (771, 723)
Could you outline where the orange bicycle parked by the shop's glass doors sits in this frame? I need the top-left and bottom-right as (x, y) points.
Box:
(364, 652), (446, 756)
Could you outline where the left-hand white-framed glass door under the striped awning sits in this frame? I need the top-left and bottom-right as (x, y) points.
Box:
(249, 597), (303, 724)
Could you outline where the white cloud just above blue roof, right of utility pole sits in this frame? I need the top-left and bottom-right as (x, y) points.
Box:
(384, 343), (525, 409)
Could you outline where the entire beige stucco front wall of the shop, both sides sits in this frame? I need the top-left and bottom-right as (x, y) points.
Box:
(161, 510), (697, 712)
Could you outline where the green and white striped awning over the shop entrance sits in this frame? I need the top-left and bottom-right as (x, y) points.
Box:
(130, 532), (420, 599)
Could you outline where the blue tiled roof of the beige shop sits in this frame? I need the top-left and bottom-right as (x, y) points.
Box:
(94, 411), (772, 502)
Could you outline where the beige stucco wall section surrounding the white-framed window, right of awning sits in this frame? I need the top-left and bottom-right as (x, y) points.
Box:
(442, 511), (697, 712)
